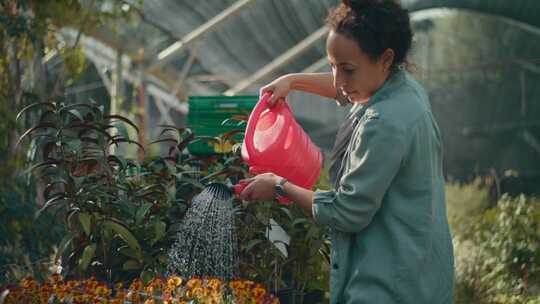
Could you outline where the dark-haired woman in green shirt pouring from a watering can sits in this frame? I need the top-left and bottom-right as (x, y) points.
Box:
(240, 0), (453, 304)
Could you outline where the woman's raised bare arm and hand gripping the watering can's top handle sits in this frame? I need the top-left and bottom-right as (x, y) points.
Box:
(260, 73), (337, 105)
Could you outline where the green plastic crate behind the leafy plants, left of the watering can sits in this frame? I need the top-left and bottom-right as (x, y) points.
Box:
(187, 96), (259, 155)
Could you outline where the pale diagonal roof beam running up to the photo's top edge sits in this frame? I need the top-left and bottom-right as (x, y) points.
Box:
(150, 0), (256, 70)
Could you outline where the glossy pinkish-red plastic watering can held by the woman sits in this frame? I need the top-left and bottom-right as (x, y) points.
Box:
(235, 92), (322, 204)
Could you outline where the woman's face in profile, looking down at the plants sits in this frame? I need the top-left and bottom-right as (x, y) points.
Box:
(326, 31), (394, 103)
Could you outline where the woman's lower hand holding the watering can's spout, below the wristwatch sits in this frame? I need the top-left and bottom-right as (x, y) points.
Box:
(239, 173), (281, 202)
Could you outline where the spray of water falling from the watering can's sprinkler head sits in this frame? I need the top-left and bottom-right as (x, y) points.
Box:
(167, 183), (238, 280)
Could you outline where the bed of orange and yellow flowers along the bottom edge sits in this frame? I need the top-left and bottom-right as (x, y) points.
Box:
(0, 275), (279, 304)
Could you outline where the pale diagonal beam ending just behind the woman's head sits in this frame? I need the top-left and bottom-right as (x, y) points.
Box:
(225, 26), (328, 96)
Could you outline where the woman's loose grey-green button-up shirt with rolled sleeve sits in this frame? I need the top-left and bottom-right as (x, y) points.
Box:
(313, 71), (454, 304)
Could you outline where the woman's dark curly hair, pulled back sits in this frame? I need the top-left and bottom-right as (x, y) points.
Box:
(326, 0), (413, 69)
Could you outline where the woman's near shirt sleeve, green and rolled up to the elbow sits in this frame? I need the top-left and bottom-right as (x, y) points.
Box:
(312, 117), (405, 232)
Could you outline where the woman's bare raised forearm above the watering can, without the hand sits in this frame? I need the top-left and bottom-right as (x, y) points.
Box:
(284, 73), (337, 99)
